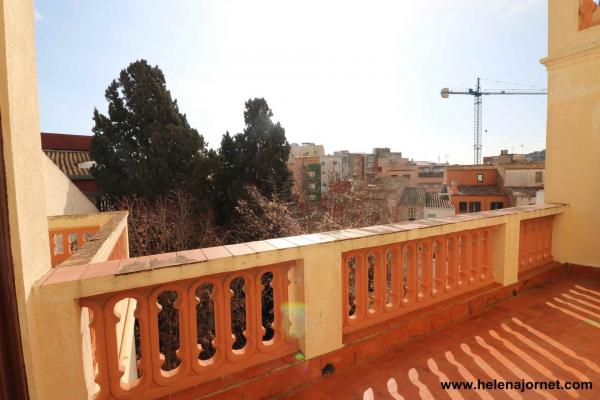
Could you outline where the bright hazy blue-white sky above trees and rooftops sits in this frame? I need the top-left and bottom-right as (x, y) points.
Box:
(35, 0), (547, 163)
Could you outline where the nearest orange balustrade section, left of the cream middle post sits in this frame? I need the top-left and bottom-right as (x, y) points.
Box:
(80, 263), (298, 399)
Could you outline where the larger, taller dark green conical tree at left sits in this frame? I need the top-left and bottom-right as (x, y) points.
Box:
(91, 60), (209, 199)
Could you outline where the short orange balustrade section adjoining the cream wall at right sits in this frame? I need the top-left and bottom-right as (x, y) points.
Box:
(519, 216), (554, 273)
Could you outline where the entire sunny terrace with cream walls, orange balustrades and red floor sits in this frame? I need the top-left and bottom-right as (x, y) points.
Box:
(0, 0), (600, 400)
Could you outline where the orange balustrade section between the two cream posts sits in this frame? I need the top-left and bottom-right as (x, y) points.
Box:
(342, 227), (494, 333)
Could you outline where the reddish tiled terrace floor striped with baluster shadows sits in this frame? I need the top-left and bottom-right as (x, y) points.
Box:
(288, 278), (600, 400)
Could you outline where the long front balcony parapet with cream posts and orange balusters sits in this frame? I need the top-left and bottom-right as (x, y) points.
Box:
(36, 205), (566, 399)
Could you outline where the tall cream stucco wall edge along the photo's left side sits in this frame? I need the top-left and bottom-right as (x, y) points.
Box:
(0, 0), (54, 399)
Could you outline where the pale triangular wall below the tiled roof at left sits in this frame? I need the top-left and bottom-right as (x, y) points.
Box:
(40, 151), (98, 216)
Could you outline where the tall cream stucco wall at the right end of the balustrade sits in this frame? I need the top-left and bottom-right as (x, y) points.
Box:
(542, 0), (600, 267)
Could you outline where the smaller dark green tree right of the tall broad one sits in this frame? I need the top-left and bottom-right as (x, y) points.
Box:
(215, 98), (293, 224)
